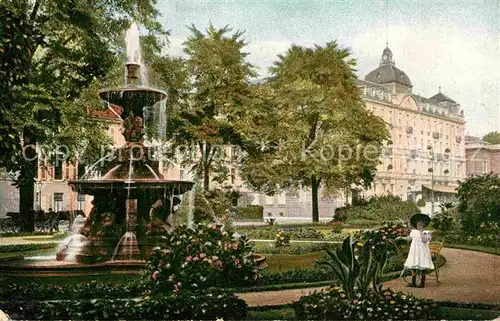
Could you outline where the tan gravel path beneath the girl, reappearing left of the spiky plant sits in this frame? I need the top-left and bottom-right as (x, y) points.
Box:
(237, 248), (500, 306)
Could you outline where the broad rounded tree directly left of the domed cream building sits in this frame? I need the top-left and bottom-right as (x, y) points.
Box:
(241, 42), (388, 222)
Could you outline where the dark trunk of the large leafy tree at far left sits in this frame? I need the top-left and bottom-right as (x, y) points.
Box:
(19, 126), (38, 232)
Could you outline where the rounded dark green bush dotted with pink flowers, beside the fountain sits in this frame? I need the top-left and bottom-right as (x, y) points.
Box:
(142, 224), (259, 295)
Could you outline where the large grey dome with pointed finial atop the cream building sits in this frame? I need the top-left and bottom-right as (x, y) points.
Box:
(365, 47), (413, 87)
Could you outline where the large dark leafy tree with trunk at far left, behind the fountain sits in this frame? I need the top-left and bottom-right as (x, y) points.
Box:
(0, 0), (165, 231)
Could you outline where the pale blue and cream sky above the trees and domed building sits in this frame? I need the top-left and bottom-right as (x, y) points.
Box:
(157, 0), (500, 136)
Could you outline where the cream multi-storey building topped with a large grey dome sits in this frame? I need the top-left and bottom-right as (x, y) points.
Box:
(359, 47), (466, 209)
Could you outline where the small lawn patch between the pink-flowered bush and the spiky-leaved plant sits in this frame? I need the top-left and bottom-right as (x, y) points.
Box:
(262, 252), (326, 274)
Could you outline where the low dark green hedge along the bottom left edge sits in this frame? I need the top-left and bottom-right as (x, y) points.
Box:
(5, 288), (248, 320)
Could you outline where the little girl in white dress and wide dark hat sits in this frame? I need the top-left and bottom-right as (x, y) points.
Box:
(398, 213), (434, 288)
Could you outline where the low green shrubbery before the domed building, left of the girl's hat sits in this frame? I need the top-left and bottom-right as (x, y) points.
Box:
(344, 196), (419, 223)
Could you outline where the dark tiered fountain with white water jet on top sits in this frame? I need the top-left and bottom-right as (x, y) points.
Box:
(57, 23), (193, 264)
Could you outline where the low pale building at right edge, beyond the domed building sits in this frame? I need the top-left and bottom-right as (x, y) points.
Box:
(465, 136), (500, 176)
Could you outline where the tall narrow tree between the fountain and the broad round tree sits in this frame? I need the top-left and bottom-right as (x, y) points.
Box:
(170, 25), (255, 191)
